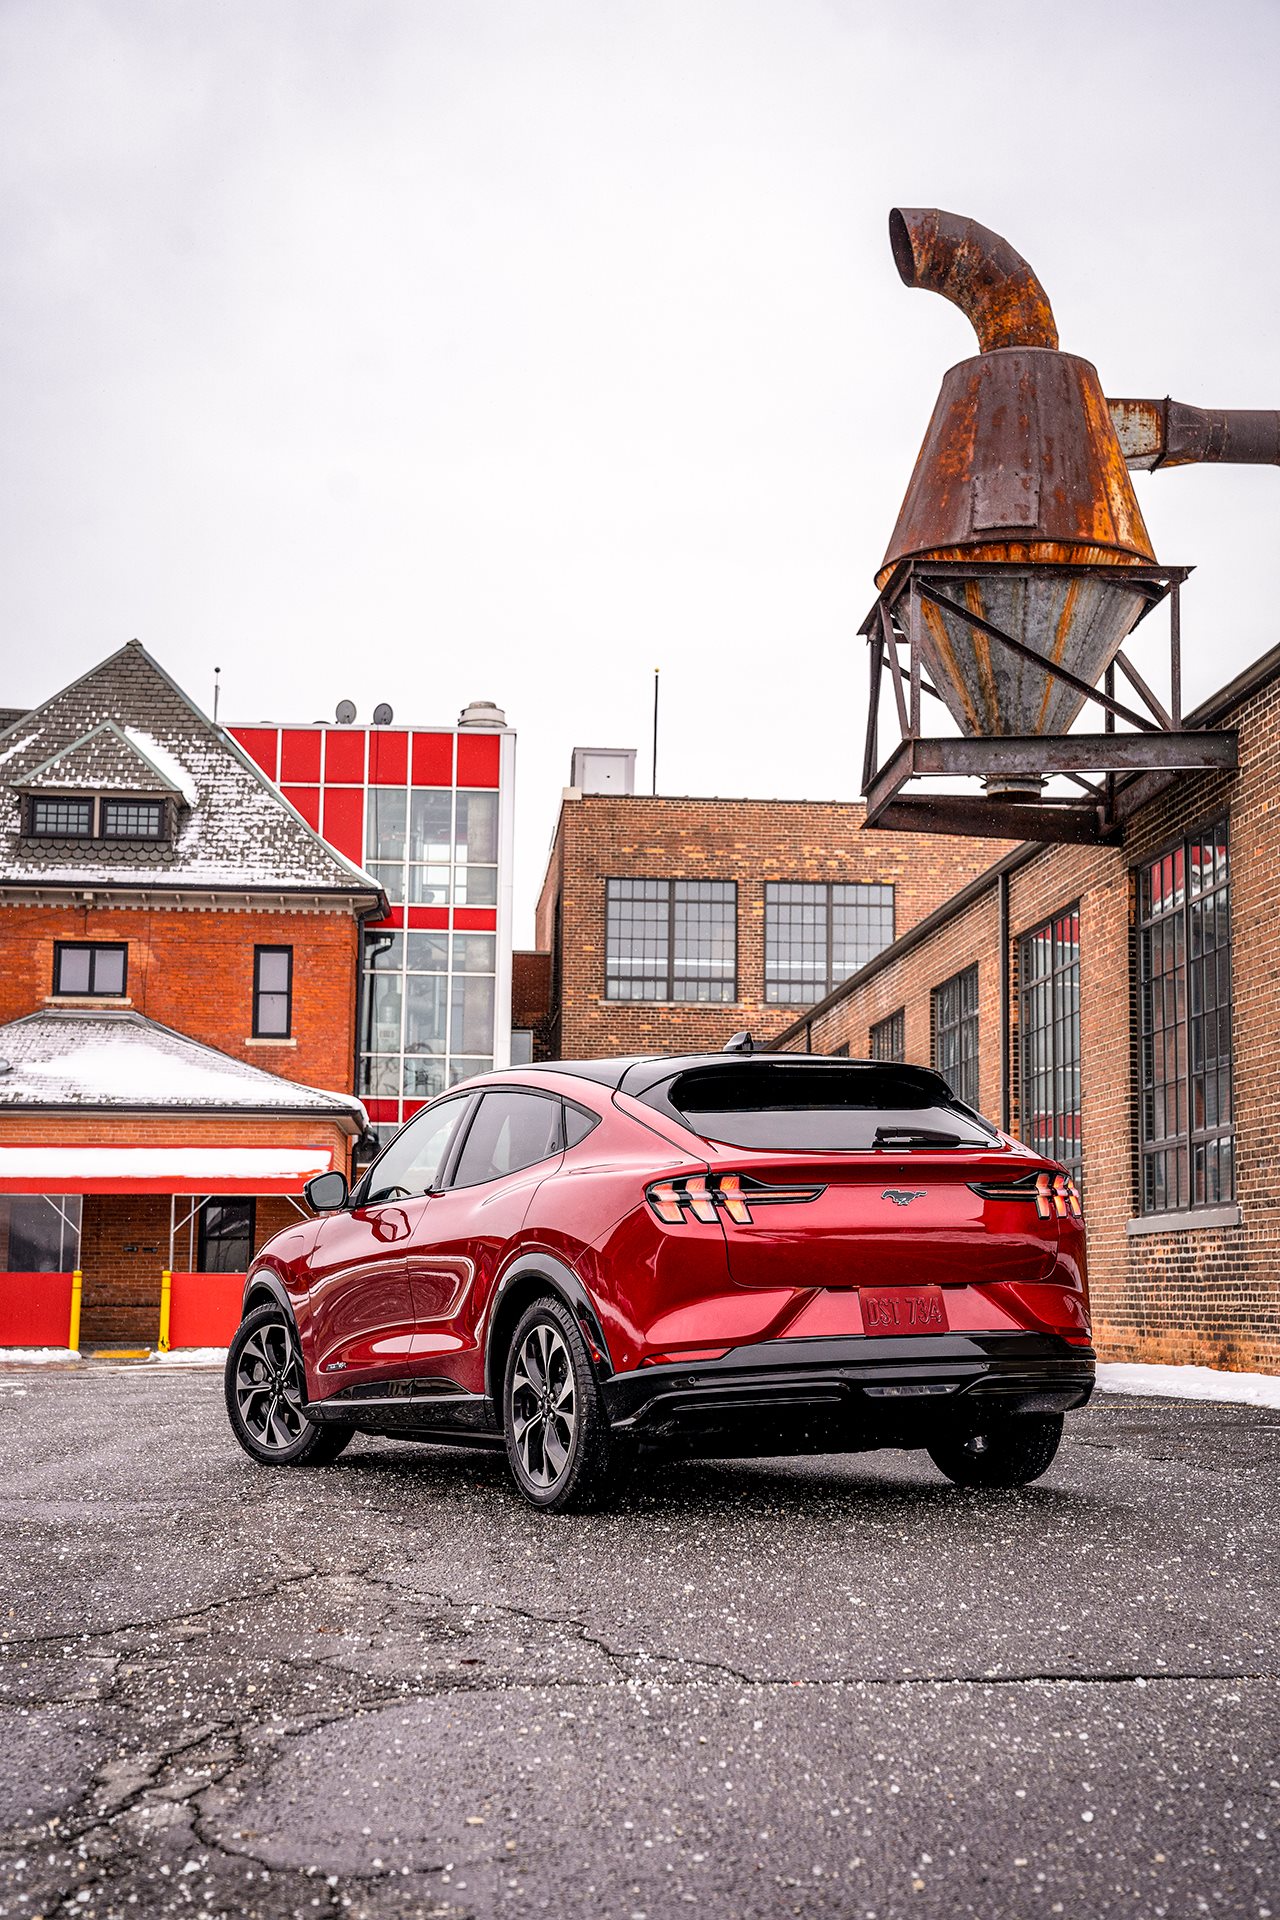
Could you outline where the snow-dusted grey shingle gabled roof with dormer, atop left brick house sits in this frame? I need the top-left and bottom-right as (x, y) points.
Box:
(0, 639), (378, 890)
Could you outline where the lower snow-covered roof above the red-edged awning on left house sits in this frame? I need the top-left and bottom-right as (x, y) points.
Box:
(0, 1008), (365, 1127)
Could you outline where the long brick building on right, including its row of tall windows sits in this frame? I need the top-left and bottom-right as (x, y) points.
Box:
(771, 649), (1280, 1371)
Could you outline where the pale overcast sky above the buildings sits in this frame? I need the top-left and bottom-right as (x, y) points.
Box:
(0, 0), (1280, 943)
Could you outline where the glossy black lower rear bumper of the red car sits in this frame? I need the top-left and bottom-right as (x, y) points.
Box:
(603, 1332), (1096, 1448)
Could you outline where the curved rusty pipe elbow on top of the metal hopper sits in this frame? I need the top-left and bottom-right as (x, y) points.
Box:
(889, 207), (1057, 353)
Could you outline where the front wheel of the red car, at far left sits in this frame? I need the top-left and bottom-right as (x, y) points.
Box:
(223, 1304), (355, 1467)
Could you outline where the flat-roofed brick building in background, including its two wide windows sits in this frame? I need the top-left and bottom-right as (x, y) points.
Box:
(518, 768), (1000, 1060)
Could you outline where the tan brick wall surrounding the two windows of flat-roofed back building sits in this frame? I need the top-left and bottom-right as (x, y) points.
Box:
(537, 793), (1007, 1060)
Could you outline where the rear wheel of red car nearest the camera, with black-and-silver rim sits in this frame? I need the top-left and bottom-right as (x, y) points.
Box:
(503, 1296), (618, 1513)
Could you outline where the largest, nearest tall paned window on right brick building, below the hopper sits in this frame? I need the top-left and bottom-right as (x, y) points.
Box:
(1138, 820), (1236, 1213)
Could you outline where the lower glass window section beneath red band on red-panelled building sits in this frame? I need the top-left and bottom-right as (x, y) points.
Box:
(361, 927), (497, 1100)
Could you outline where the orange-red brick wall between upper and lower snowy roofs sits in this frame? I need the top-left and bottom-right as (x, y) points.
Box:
(0, 904), (359, 1092)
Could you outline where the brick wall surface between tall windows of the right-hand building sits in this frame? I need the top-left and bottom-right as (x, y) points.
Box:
(773, 680), (1280, 1371)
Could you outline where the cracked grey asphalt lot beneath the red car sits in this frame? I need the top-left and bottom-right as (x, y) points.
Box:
(0, 1369), (1280, 1920)
